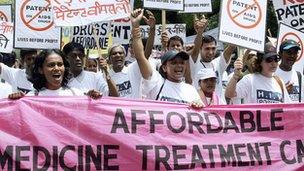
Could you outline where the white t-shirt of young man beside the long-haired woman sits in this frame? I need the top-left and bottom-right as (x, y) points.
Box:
(68, 70), (109, 96)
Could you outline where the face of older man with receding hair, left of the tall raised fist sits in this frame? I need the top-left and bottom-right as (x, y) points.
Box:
(109, 46), (126, 72)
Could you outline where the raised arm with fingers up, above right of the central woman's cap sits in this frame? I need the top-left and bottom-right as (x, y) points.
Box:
(189, 15), (208, 63)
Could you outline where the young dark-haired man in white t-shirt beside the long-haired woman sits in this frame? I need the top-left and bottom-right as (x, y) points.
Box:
(62, 42), (118, 97)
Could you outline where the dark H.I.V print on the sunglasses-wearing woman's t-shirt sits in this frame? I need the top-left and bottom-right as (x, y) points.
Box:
(257, 90), (282, 103)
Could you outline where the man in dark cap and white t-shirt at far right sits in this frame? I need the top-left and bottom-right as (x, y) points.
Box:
(276, 39), (304, 102)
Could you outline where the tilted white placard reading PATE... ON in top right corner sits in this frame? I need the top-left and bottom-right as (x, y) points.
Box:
(272, 0), (304, 32)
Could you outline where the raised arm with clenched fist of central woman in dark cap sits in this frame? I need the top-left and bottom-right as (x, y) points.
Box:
(130, 9), (153, 79)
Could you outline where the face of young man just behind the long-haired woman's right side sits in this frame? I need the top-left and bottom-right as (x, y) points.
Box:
(67, 50), (85, 76)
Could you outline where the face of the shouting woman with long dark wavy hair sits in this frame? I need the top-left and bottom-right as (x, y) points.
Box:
(41, 53), (65, 90)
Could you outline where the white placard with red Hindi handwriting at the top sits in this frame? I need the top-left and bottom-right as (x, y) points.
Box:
(51, 0), (131, 26)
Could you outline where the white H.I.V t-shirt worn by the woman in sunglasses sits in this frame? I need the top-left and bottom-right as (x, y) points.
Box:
(236, 73), (291, 104)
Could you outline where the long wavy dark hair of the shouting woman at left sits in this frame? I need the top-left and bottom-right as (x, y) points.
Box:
(28, 49), (71, 91)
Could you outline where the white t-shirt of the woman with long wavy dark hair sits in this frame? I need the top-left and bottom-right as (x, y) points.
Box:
(26, 87), (84, 96)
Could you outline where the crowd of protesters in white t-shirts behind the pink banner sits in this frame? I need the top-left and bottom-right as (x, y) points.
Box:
(0, 9), (303, 107)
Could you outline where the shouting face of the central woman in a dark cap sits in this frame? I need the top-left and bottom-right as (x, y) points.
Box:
(163, 57), (186, 82)
